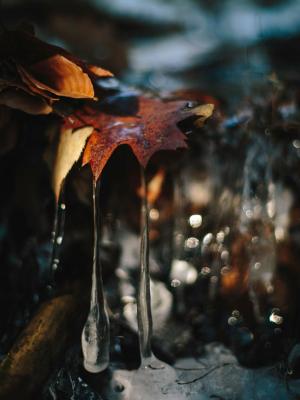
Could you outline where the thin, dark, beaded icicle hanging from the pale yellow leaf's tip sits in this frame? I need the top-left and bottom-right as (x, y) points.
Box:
(50, 183), (66, 285)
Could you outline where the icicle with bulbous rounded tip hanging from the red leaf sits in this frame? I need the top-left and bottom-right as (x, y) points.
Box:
(81, 182), (110, 373)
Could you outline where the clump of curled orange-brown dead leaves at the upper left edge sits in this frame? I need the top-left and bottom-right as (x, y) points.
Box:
(0, 30), (112, 114)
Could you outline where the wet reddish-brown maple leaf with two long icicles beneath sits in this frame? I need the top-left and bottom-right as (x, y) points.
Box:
(65, 97), (213, 180)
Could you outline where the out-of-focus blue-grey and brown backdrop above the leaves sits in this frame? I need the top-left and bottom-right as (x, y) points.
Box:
(2, 0), (300, 99)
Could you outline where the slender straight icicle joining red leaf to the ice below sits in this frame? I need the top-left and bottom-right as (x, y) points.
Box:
(137, 168), (153, 366)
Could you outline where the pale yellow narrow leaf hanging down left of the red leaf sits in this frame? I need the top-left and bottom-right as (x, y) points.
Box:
(52, 126), (93, 201)
